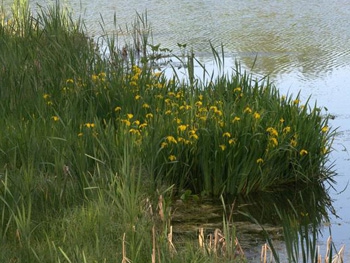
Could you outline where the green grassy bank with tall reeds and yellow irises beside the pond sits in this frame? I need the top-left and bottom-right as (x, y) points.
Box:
(0, 2), (335, 262)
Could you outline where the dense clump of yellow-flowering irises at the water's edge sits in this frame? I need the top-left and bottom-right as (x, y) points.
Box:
(43, 58), (329, 196)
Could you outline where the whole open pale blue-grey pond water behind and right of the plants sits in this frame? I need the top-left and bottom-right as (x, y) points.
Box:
(5, 0), (350, 258)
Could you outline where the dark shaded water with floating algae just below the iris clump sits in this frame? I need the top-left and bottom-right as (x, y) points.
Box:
(172, 185), (334, 262)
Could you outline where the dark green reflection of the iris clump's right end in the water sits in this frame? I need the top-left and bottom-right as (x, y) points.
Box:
(240, 185), (334, 262)
